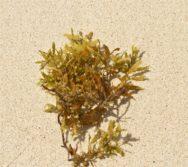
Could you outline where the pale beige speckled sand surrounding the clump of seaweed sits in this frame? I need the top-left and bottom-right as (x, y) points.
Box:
(0, 0), (188, 167)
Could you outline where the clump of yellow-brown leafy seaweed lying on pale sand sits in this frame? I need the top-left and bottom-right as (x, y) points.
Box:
(37, 30), (149, 167)
